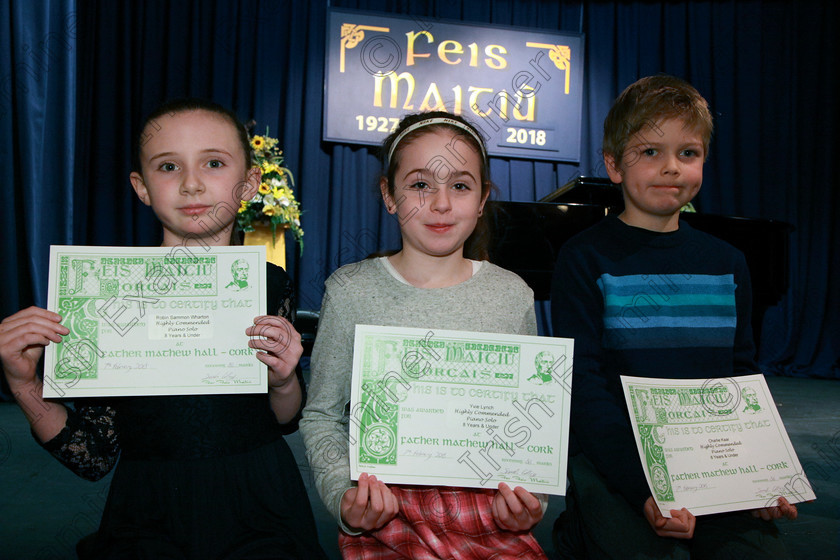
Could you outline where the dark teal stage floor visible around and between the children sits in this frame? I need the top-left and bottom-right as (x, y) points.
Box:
(0, 378), (840, 560)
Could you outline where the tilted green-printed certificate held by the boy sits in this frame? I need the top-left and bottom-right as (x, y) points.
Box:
(621, 374), (815, 517)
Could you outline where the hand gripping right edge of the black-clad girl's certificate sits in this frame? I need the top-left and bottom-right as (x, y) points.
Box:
(245, 315), (303, 388)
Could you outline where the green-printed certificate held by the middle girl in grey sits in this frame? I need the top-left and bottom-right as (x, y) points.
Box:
(350, 325), (572, 495)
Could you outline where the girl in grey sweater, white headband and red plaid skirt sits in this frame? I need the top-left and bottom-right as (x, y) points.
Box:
(300, 112), (545, 559)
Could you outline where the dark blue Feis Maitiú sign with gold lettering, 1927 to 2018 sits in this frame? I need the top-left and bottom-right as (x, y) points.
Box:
(324, 9), (583, 162)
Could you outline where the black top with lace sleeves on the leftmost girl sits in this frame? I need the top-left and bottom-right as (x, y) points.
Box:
(43, 264), (305, 480)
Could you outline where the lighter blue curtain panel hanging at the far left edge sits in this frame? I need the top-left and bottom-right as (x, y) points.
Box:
(0, 0), (79, 324)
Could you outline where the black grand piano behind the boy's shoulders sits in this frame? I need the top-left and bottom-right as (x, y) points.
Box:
(486, 177), (793, 343)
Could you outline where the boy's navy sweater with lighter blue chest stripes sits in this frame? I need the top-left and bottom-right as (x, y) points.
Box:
(551, 216), (758, 512)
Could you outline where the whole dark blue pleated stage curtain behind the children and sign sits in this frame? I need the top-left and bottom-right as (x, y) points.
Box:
(0, 0), (840, 390)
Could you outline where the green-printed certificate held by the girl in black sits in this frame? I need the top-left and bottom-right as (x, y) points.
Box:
(44, 246), (268, 397)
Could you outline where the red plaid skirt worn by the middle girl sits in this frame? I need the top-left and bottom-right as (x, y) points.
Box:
(338, 485), (547, 560)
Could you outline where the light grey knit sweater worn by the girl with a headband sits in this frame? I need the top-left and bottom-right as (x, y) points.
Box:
(300, 259), (537, 532)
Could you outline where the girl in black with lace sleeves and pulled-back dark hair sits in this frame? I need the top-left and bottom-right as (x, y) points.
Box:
(0, 99), (324, 560)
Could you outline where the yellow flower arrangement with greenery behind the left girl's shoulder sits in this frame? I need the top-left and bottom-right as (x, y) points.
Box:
(236, 129), (303, 253)
